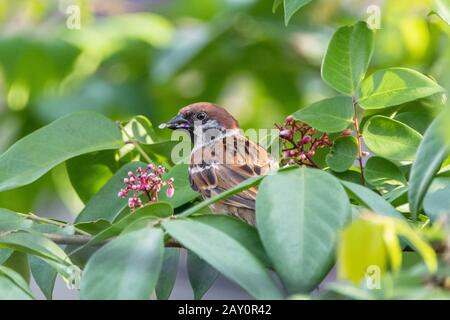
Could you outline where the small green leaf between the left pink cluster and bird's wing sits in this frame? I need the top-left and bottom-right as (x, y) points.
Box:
(159, 164), (200, 208)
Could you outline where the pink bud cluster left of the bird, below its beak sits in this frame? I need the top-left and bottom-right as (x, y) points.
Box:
(118, 164), (175, 210)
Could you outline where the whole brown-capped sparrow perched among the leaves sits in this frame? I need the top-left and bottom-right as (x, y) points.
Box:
(160, 102), (278, 226)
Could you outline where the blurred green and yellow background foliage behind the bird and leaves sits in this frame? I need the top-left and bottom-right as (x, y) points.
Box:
(0, 0), (450, 299)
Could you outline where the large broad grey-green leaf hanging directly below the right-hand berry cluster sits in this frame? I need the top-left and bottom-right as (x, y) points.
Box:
(256, 168), (351, 294)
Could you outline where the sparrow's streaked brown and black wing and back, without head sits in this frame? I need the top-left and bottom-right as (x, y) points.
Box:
(189, 135), (277, 210)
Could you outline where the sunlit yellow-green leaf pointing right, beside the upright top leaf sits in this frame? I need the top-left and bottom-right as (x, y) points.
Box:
(358, 68), (445, 109)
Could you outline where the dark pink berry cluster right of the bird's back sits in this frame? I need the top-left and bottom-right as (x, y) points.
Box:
(276, 116), (333, 167)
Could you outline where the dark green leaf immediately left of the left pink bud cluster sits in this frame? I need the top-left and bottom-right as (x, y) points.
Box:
(75, 162), (146, 223)
